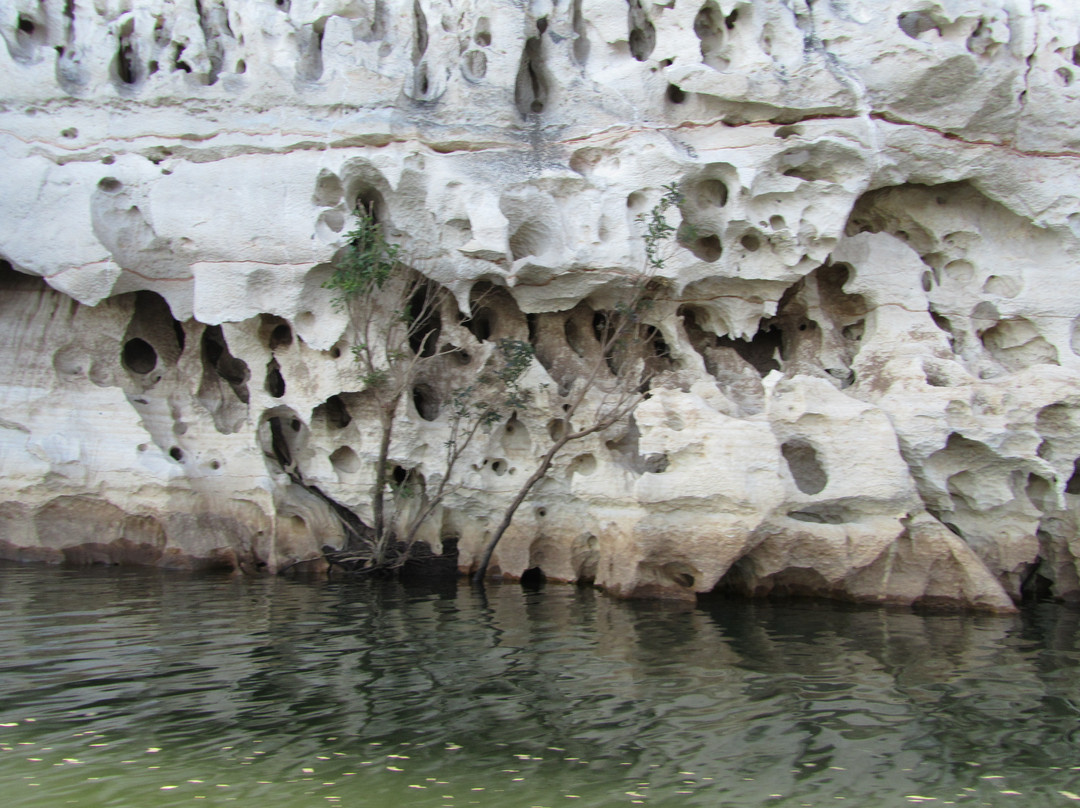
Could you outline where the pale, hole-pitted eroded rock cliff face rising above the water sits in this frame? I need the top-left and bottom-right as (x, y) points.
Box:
(6, 0), (1080, 609)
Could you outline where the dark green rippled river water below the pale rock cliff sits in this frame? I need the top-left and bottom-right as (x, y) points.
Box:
(0, 566), (1080, 808)
